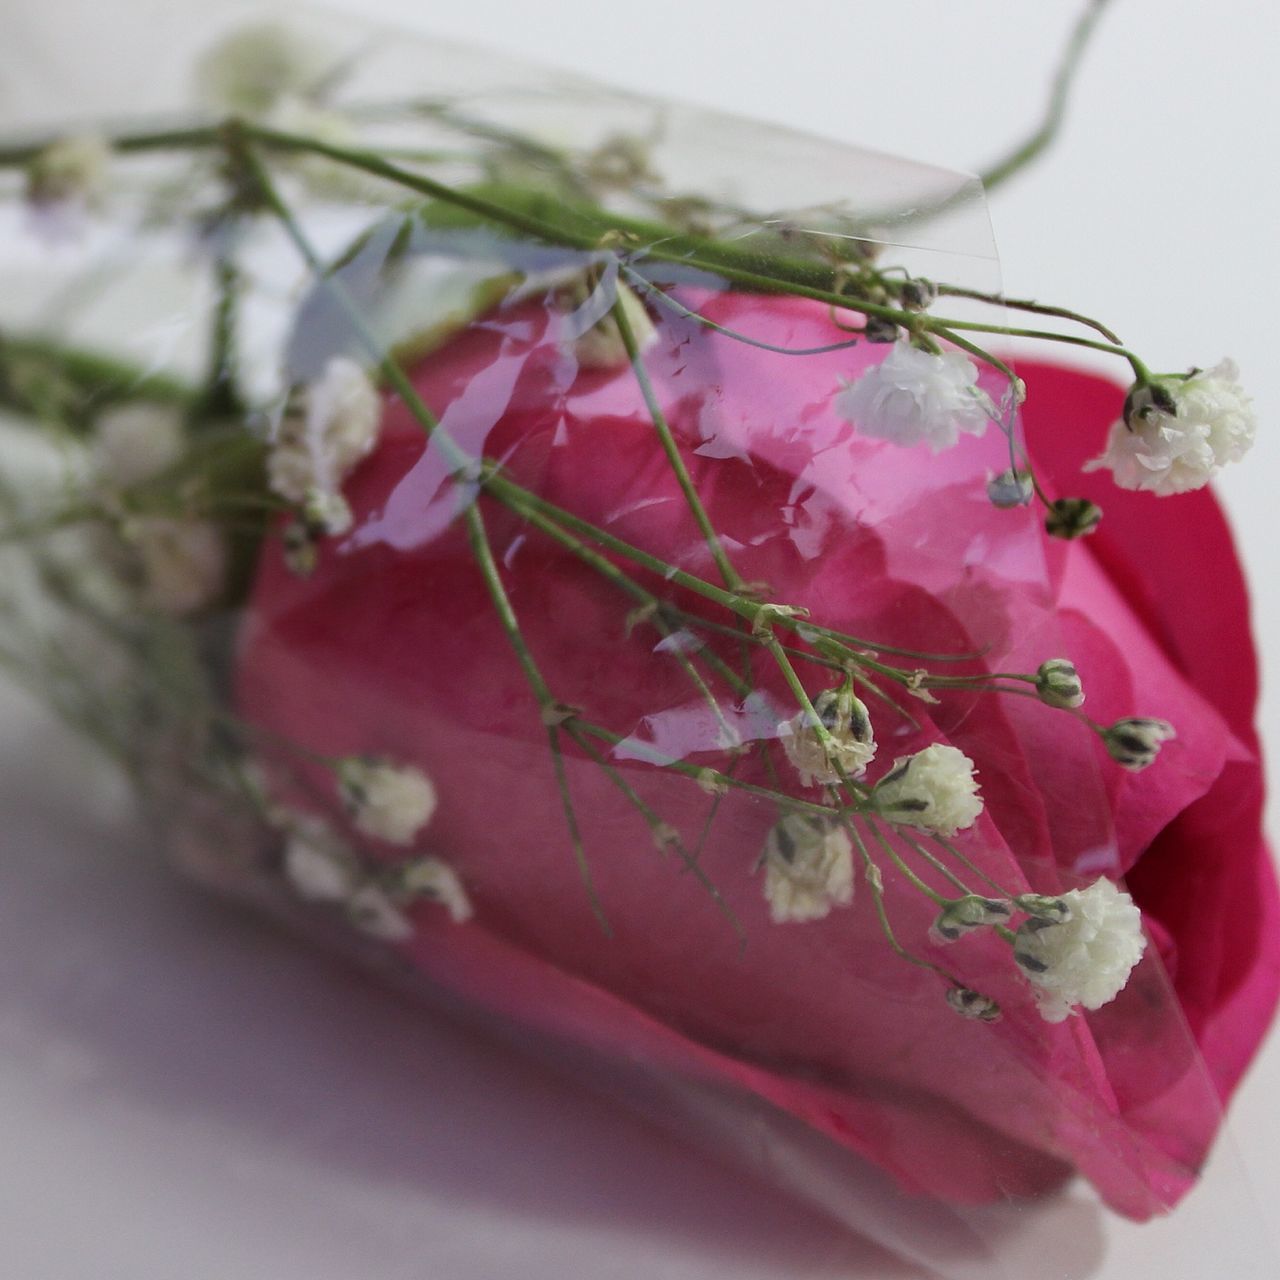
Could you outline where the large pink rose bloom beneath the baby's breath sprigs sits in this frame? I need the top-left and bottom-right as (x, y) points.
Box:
(238, 294), (1280, 1217)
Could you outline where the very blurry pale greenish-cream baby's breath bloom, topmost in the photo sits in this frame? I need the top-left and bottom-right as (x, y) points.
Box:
(196, 22), (334, 118)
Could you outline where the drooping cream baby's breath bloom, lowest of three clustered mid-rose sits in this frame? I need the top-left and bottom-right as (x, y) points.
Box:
(764, 814), (854, 924)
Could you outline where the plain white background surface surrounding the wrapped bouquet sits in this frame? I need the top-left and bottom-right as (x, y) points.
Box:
(0, 0), (1280, 1280)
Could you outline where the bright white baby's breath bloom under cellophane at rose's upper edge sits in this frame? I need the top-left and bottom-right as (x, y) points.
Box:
(835, 342), (992, 453)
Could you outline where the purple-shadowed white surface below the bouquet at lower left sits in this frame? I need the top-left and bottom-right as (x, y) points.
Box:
(0, 704), (923, 1280)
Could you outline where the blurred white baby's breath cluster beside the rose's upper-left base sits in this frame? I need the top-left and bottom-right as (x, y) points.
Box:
(266, 356), (383, 531)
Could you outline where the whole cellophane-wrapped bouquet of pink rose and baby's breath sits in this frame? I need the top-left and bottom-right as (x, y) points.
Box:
(0, 5), (1280, 1274)
